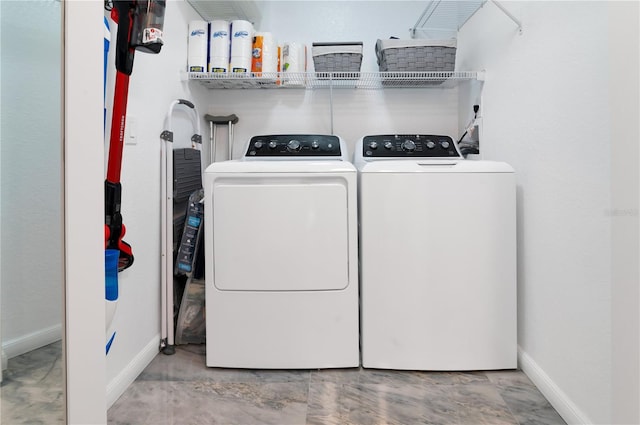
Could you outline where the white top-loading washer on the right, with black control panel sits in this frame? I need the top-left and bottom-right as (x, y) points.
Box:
(354, 135), (517, 371)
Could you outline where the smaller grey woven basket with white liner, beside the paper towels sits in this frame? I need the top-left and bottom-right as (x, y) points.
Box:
(311, 41), (362, 72)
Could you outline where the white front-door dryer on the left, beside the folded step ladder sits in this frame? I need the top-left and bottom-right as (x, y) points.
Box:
(204, 134), (360, 369)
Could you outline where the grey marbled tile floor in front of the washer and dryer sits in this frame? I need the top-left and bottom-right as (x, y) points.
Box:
(108, 345), (565, 425)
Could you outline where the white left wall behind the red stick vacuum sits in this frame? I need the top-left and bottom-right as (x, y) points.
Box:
(105, 0), (211, 405)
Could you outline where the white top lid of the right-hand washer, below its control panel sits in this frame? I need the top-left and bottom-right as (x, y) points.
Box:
(359, 159), (514, 173)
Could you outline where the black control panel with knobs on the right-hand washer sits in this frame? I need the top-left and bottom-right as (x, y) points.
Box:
(362, 134), (461, 158)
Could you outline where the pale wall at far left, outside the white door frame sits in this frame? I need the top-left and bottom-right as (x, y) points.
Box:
(0, 1), (63, 357)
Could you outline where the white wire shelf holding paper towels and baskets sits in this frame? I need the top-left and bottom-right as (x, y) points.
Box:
(189, 71), (484, 89)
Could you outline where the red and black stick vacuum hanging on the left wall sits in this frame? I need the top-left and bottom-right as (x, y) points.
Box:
(104, 0), (166, 271)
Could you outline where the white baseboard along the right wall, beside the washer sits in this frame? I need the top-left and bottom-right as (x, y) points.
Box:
(518, 347), (593, 425)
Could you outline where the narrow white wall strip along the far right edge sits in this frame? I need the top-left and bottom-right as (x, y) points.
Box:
(608, 2), (640, 424)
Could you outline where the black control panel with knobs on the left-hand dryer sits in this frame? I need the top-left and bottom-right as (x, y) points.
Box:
(246, 134), (342, 157)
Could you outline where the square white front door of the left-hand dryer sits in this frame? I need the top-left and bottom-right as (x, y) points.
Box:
(209, 174), (349, 291)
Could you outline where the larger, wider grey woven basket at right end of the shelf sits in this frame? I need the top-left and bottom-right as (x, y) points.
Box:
(376, 39), (456, 72)
